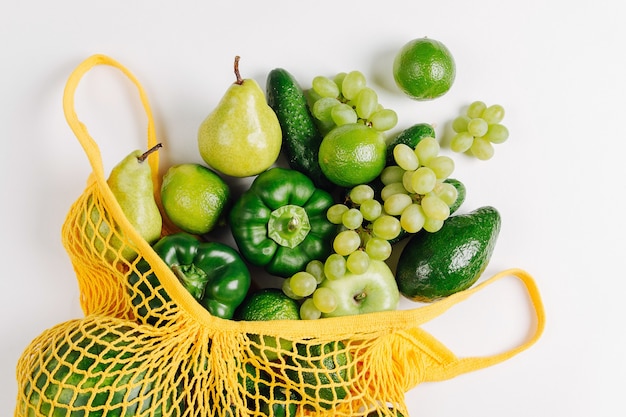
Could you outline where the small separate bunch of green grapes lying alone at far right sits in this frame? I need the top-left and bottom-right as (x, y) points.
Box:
(450, 101), (509, 160)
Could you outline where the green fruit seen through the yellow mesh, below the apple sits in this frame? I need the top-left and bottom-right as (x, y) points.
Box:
(285, 342), (354, 410)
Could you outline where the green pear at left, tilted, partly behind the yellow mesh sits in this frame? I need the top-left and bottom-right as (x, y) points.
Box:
(83, 144), (163, 263)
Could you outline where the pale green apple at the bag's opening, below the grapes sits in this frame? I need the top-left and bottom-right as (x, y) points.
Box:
(320, 260), (400, 317)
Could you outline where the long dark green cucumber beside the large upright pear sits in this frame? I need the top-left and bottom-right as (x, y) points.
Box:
(266, 68), (334, 191)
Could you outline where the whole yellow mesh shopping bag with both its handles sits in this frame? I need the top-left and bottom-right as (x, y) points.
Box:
(15, 55), (545, 417)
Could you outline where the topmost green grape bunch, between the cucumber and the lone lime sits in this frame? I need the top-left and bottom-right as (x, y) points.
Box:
(308, 71), (398, 133)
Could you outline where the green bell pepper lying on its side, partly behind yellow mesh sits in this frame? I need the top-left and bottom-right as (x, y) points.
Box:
(130, 233), (251, 324)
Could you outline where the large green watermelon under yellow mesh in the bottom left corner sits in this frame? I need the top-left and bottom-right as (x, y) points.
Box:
(18, 320), (184, 417)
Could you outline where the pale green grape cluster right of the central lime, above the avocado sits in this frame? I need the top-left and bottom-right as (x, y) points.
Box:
(380, 137), (458, 233)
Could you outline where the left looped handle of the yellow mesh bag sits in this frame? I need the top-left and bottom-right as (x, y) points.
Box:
(63, 54), (159, 202)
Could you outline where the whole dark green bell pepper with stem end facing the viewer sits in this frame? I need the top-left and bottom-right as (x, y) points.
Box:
(229, 167), (337, 278)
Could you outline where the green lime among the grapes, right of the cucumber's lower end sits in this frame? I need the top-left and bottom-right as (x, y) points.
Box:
(319, 123), (387, 187)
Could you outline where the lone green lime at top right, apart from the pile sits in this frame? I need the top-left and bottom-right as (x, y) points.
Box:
(393, 38), (456, 100)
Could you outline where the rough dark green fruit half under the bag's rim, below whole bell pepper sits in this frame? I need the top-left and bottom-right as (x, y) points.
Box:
(235, 288), (300, 361)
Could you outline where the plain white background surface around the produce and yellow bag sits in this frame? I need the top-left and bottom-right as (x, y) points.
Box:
(0, 0), (626, 417)
